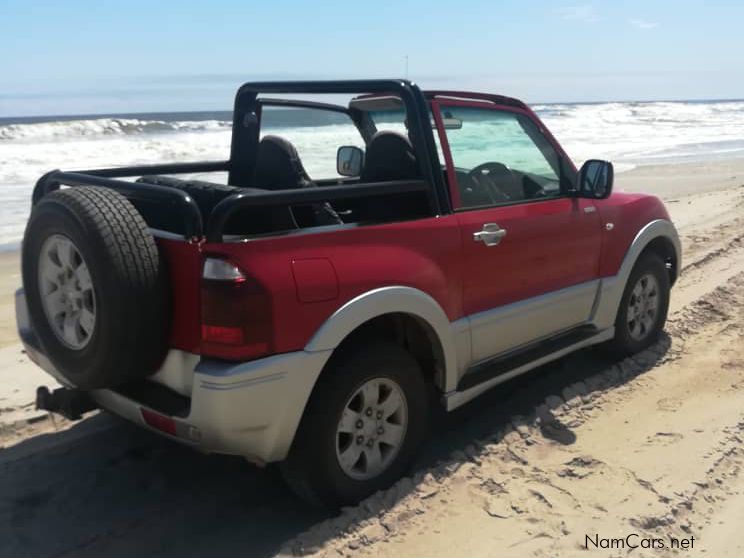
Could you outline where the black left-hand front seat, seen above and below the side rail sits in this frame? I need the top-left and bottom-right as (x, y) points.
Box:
(252, 136), (342, 227)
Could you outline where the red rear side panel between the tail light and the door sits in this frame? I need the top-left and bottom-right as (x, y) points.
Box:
(202, 215), (463, 358)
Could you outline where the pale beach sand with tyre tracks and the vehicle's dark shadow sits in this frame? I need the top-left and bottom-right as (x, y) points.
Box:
(0, 161), (744, 558)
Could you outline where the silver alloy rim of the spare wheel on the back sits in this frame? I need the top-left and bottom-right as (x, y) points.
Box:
(39, 234), (96, 351)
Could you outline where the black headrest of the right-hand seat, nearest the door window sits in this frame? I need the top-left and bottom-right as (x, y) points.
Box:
(360, 130), (421, 182)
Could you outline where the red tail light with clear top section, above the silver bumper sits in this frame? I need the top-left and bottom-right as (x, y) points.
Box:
(201, 257), (272, 359)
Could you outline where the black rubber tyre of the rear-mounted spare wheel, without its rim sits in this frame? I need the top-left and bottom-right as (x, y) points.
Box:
(23, 186), (170, 389)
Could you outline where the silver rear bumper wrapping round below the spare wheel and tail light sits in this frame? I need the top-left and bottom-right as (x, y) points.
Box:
(16, 290), (331, 463)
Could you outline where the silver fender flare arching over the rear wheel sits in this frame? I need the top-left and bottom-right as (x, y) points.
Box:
(305, 286), (457, 388)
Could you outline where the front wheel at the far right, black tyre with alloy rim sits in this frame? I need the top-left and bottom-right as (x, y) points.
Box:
(607, 252), (670, 357)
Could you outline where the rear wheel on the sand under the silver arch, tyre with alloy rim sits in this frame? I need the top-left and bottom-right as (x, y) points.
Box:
(280, 340), (429, 508)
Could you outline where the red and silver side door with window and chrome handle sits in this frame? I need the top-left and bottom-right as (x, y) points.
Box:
(433, 100), (601, 362)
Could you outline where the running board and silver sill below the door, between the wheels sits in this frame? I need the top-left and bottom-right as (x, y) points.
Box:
(444, 326), (615, 411)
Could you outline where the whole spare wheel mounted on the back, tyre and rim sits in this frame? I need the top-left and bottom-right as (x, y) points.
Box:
(22, 187), (170, 389)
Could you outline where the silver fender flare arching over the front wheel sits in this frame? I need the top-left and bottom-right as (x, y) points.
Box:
(593, 219), (682, 329)
